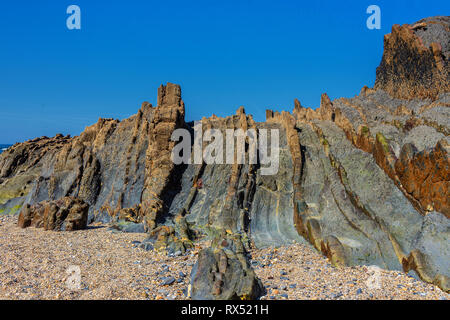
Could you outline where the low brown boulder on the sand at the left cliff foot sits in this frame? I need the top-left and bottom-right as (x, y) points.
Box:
(18, 197), (89, 231)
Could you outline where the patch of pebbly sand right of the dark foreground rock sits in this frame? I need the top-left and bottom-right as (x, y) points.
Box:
(252, 244), (450, 300)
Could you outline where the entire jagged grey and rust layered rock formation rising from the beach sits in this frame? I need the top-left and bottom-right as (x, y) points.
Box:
(0, 17), (450, 299)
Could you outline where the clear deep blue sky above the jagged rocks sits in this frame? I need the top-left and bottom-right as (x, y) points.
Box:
(0, 0), (450, 143)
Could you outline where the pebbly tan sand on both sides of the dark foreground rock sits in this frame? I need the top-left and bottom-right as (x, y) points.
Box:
(0, 216), (450, 299)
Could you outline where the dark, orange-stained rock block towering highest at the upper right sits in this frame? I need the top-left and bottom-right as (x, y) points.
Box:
(375, 17), (450, 99)
